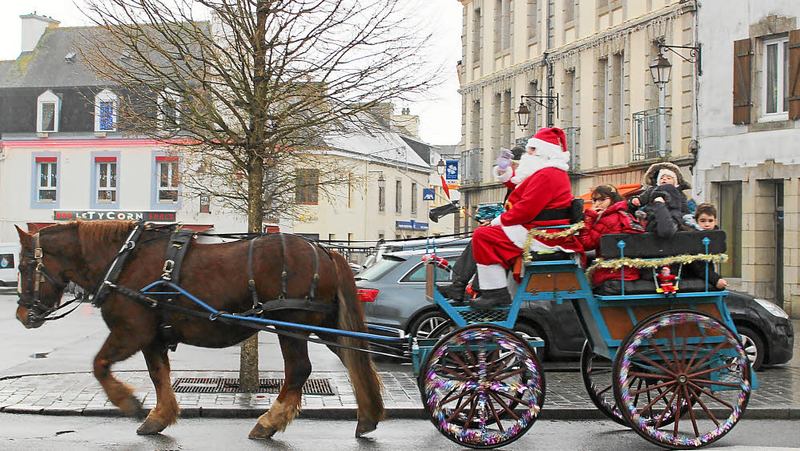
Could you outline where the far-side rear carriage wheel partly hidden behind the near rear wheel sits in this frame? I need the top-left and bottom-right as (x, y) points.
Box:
(581, 340), (685, 427)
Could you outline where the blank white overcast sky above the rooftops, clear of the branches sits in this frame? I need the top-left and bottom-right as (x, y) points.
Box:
(0, 0), (462, 144)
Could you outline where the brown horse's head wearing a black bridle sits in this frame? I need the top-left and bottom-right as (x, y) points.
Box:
(17, 227), (68, 329)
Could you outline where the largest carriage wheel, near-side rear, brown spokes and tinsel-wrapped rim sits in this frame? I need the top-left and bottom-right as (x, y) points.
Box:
(613, 310), (751, 449)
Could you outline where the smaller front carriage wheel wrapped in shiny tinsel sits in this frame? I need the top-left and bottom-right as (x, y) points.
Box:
(420, 324), (545, 449)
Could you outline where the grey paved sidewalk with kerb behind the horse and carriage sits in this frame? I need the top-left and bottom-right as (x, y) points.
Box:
(0, 367), (800, 419)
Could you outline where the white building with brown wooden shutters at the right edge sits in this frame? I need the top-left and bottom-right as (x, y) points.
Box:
(694, 0), (800, 318)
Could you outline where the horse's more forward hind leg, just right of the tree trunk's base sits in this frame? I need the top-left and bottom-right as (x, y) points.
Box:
(249, 335), (311, 439)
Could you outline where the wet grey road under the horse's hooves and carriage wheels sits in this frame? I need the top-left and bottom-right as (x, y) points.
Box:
(0, 414), (800, 451)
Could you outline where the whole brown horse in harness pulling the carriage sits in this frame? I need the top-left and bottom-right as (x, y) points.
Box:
(17, 221), (384, 439)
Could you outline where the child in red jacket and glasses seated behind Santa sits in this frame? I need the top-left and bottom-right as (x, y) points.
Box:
(578, 185), (644, 286)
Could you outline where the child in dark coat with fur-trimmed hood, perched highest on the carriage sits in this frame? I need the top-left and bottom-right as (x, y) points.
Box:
(629, 163), (690, 239)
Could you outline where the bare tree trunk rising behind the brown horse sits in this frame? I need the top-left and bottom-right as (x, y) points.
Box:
(239, 0), (269, 393)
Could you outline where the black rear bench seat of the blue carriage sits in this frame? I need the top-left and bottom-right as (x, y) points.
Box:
(594, 230), (726, 295)
